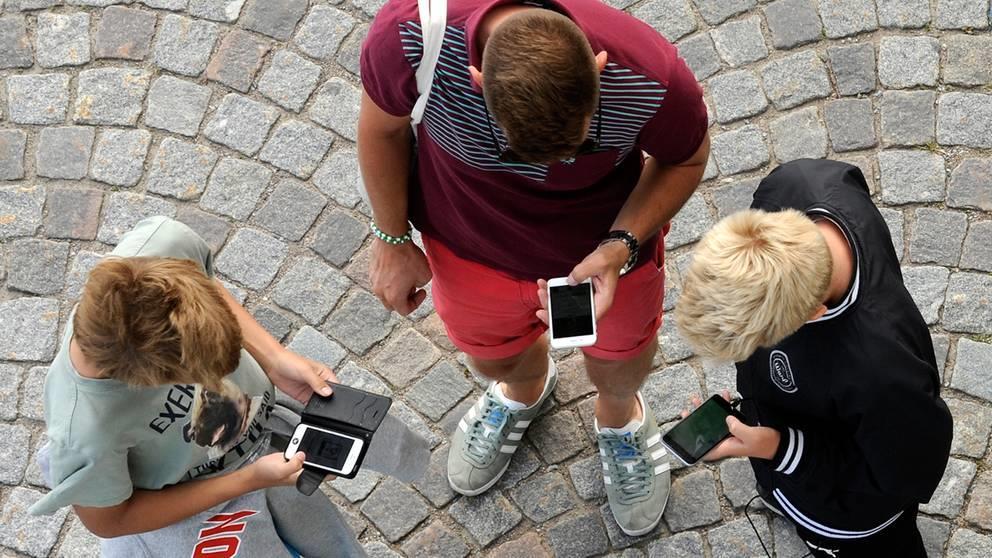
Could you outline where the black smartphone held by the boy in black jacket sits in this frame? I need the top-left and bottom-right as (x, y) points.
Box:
(661, 395), (744, 465)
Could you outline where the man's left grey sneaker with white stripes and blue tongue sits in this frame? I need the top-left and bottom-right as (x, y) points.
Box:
(448, 359), (558, 496)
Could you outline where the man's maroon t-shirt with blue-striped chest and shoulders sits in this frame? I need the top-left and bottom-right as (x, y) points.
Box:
(361, 0), (707, 280)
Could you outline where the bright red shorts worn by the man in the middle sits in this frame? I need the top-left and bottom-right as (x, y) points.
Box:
(424, 236), (665, 360)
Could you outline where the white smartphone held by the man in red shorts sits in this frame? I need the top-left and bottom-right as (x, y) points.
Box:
(548, 277), (596, 349)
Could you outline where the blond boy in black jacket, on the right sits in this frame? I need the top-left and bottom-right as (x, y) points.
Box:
(676, 160), (951, 557)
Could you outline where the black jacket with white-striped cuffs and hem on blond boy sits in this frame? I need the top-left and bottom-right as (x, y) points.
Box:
(737, 160), (951, 539)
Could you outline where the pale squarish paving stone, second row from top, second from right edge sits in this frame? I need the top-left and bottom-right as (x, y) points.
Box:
(878, 37), (940, 89)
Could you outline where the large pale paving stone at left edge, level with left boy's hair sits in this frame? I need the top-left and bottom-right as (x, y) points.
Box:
(0, 297), (59, 361)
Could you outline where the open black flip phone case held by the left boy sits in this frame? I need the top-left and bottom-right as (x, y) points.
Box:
(296, 382), (393, 495)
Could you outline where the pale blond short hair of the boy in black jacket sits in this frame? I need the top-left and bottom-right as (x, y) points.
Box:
(675, 209), (833, 362)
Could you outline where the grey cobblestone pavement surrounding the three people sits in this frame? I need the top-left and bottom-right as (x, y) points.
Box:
(0, 0), (992, 558)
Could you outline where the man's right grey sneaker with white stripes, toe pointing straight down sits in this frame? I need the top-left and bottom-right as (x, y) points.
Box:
(596, 393), (672, 537)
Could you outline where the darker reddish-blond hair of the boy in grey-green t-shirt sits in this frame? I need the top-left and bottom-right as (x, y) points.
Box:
(72, 257), (241, 390)
